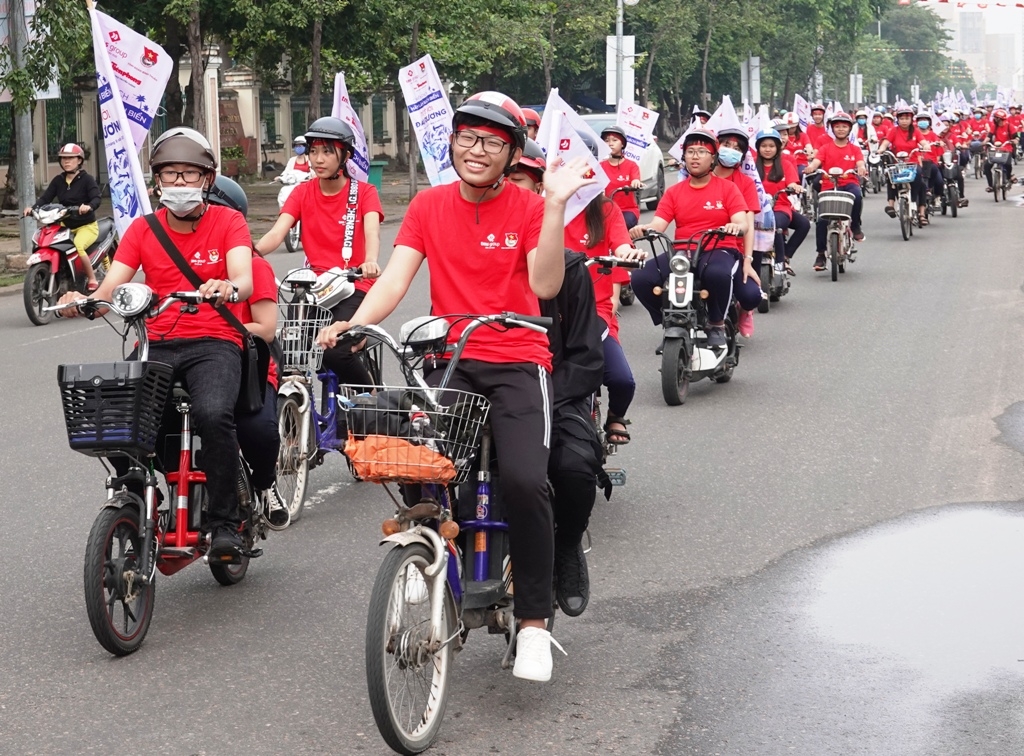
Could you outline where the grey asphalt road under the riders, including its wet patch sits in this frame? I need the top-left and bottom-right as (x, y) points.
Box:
(0, 174), (1024, 755)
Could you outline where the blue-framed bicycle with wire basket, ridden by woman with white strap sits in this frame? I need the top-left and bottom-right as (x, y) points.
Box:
(278, 268), (381, 522)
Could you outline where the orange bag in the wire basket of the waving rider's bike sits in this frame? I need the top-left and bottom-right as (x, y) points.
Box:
(345, 435), (456, 482)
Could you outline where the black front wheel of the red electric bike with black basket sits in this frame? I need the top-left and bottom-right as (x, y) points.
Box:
(84, 505), (156, 657)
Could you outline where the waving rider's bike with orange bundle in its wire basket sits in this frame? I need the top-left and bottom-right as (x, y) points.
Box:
(327, 312), (551, 754)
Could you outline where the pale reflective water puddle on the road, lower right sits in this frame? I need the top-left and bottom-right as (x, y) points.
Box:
(806, 507), (1024, 688)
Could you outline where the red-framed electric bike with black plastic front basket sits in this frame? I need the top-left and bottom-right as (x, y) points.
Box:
(50, 283), (272, 657)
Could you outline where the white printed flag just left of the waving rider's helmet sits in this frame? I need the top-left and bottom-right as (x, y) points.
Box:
(398, 55), (459, 186)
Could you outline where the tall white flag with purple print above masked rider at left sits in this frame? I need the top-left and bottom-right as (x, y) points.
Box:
(89, 8), (171, 237)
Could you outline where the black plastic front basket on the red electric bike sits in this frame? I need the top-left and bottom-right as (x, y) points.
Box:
(57, 362), (173, 457)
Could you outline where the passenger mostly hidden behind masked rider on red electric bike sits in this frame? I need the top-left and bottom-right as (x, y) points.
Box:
(207, 176), (291, 531)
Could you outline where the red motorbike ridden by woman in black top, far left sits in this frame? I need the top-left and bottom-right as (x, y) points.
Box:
(23, 205), (118, 326)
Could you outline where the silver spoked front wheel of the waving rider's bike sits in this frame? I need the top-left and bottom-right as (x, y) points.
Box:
(366, 543), (456, 754)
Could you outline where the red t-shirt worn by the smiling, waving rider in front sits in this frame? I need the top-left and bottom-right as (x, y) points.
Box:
(394, 181), (551, 371)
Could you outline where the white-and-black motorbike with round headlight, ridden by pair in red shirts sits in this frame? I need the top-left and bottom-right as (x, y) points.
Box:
(642, 229), (740, 407)
